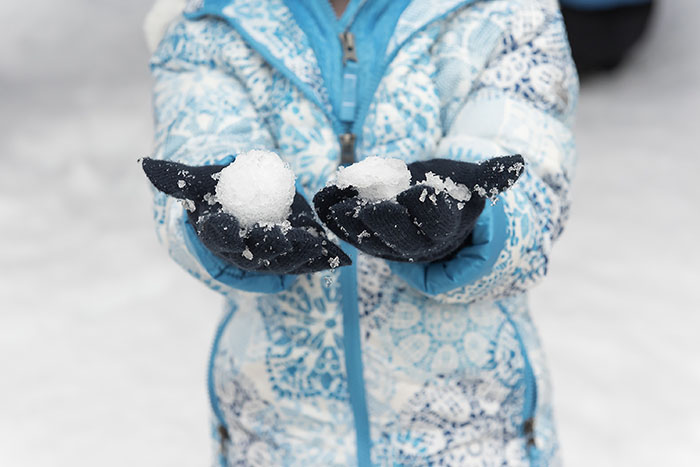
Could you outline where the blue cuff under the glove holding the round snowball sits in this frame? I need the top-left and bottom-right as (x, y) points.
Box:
(182, 216), (296, 293)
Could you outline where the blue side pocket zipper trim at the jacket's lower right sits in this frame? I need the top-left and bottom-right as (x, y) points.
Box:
(498, 303), (540, 467)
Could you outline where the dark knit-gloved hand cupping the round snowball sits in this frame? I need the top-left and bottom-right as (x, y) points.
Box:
(142, 158), (352, 274)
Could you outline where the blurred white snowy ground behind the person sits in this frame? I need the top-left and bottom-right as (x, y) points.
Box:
(0, 0), (700, 467)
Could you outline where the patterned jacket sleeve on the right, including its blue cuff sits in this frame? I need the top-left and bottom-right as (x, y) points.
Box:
(390, 2), (578, 303)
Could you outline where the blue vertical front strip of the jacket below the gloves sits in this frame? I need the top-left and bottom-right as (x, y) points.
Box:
(340, 247), (372, 467)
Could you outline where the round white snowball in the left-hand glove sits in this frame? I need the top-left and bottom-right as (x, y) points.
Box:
(214, 150), (296, 228)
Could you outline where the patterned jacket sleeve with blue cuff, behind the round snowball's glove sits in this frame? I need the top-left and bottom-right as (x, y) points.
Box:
(151, 18), (294, 295)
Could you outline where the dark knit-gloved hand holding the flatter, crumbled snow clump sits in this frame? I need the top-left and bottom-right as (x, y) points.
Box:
(314, 155), (524, 262)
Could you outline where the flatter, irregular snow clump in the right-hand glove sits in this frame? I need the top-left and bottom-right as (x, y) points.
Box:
(333, 156), (411, 201)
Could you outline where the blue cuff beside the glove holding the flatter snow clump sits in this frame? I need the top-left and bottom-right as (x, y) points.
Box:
(388, 200), (508, 295)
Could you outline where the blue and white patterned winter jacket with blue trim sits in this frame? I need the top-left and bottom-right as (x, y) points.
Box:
(145, 0), (578, 467)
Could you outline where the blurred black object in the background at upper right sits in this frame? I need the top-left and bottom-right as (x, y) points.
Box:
(560, 0), (653, 76)
